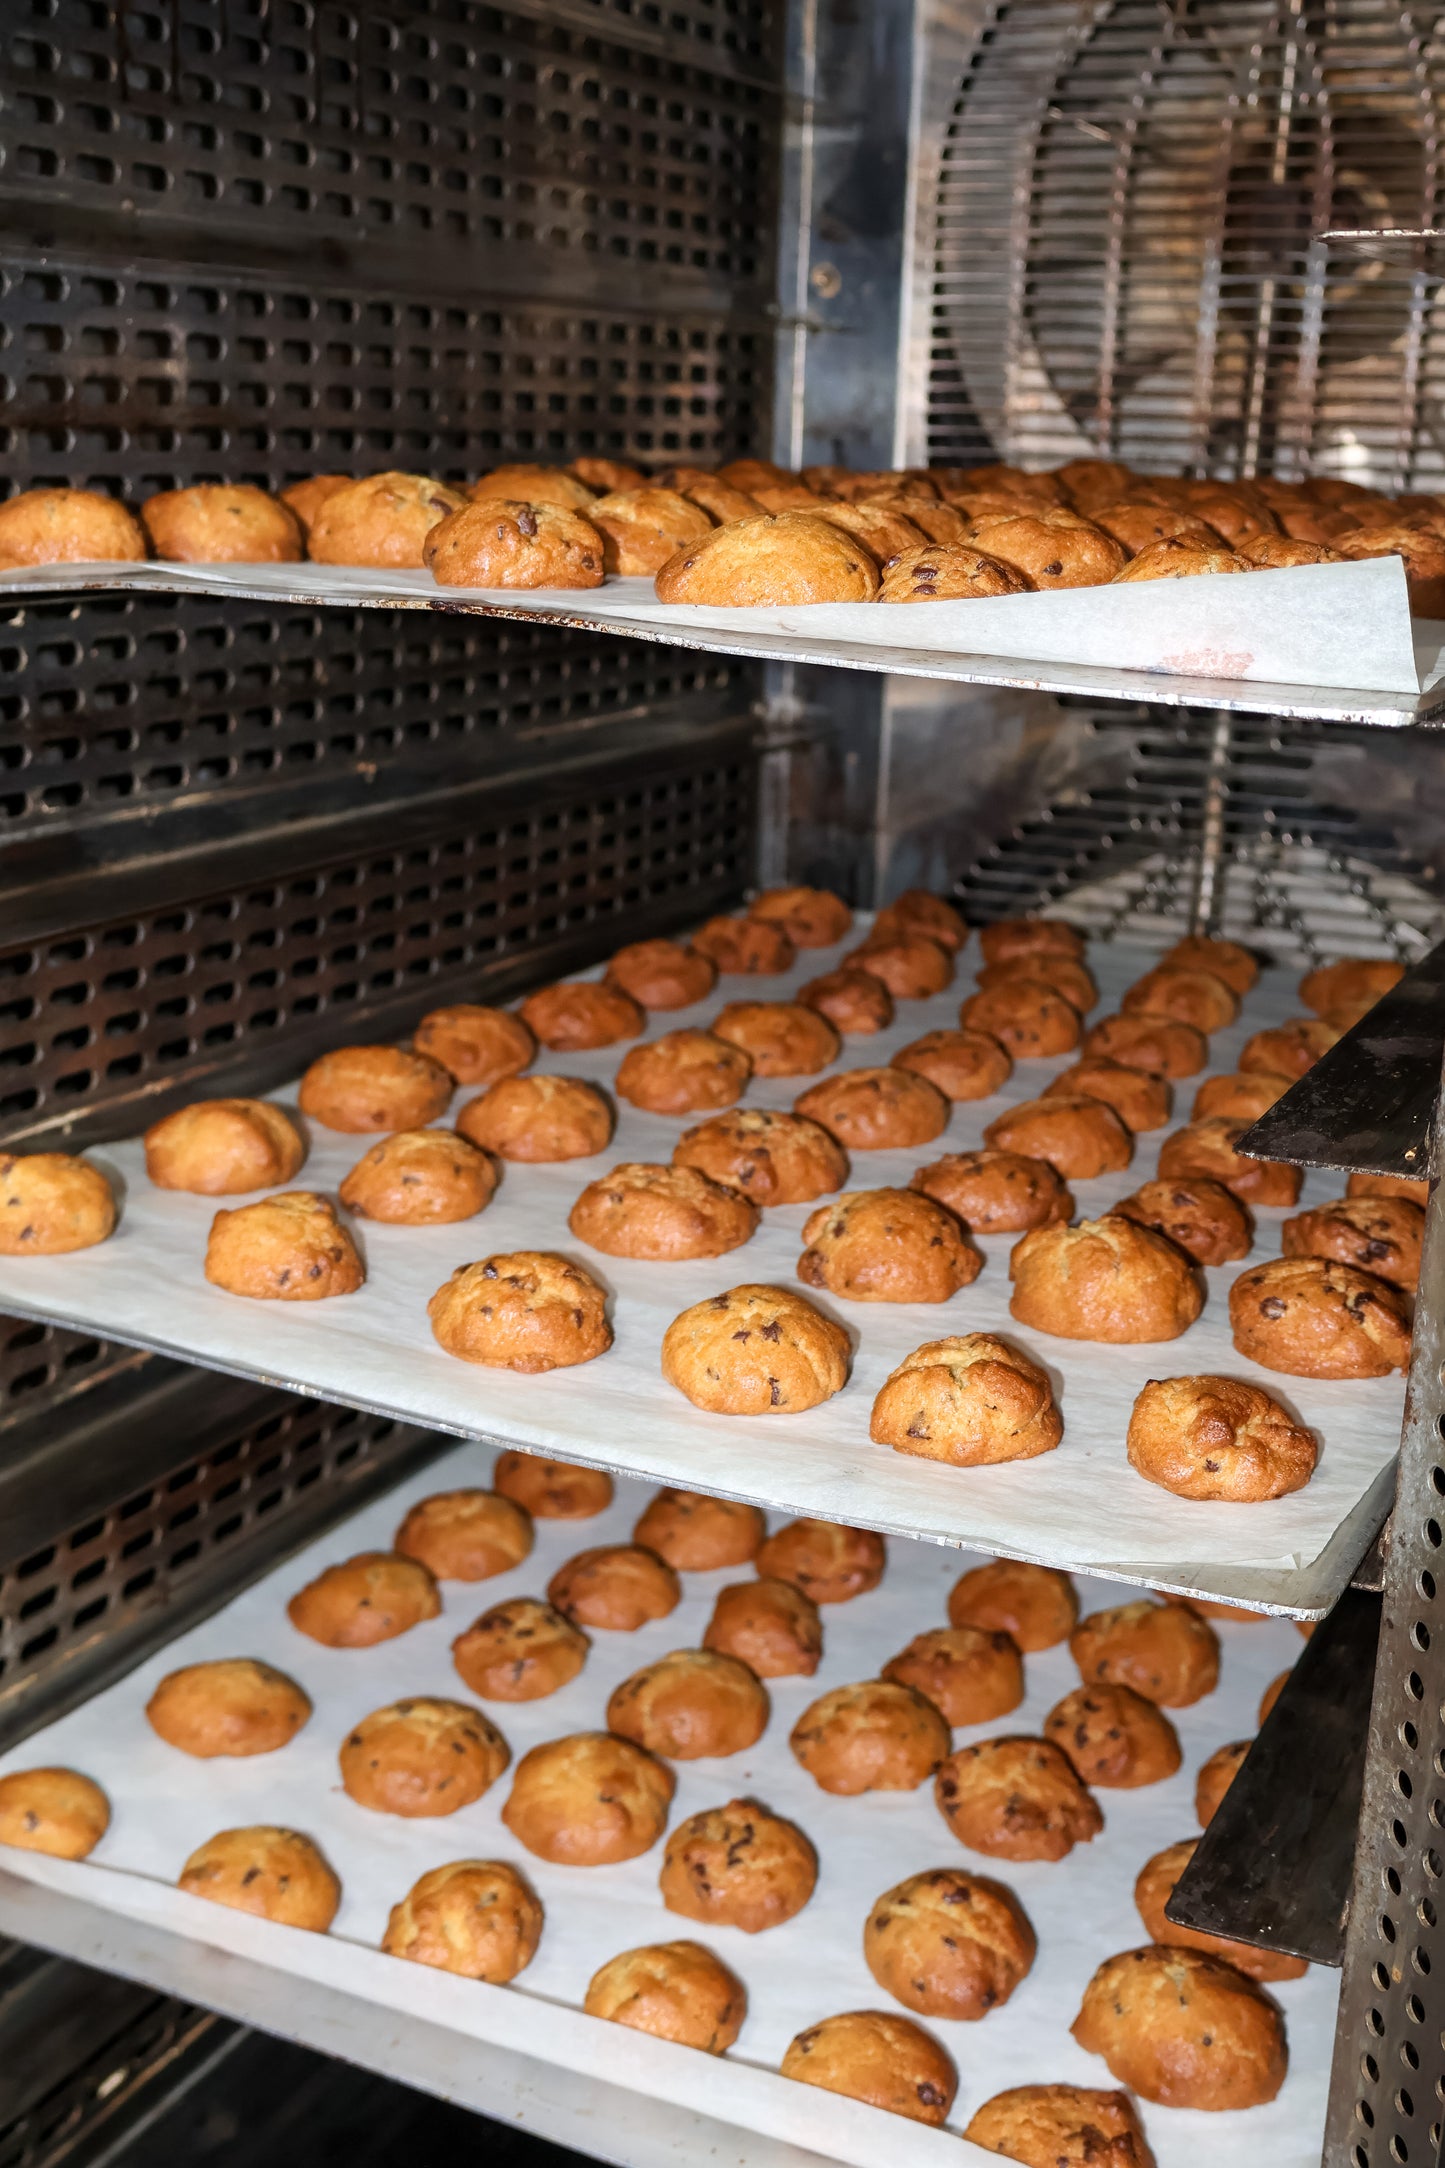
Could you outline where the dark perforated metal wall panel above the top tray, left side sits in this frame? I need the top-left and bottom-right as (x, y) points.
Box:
(0, 0), (780, 492)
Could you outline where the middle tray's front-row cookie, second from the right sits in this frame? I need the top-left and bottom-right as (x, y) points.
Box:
(869, 1333), (1064, 1468)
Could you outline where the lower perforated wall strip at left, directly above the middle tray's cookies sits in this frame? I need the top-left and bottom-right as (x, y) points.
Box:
(0, 750), (756, 1134)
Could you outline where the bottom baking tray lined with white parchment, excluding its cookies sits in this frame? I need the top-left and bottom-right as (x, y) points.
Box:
(0, 1446), (1337, 2168)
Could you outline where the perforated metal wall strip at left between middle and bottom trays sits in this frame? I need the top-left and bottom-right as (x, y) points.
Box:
(0, 1392), (422, 1719)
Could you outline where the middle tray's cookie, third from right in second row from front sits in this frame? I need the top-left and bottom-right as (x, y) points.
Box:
(797, 1190), (984, 1303)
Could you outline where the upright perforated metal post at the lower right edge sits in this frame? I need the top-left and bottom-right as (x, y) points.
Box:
(1324, 1084), (1445, 2168)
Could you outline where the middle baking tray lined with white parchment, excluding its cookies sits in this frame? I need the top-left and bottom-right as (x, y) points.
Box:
(0, 921), (1402, 1617)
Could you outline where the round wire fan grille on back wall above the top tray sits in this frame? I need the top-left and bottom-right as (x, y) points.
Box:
(929, 0), (1445, 488)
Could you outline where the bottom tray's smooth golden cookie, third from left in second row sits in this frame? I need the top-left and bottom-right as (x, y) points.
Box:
(503, 1732), (676, 1867)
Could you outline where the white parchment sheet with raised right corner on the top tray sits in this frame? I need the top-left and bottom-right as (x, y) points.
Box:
(0, 557), (1421, 694)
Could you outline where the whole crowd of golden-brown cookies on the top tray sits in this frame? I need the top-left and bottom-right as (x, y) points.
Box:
(11, 460), (1445, 616)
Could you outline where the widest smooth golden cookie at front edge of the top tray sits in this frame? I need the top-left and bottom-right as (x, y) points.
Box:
(656, 511), (877, 609)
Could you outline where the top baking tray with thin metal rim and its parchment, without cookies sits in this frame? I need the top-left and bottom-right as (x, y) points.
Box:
(0, 557), (1445, 728)
